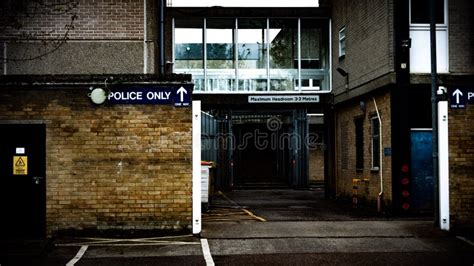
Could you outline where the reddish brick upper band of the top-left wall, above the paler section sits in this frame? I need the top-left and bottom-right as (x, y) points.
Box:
(0, 0), (144, 40)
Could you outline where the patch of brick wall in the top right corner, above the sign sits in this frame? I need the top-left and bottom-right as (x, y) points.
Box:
(448, 0), (474, 74)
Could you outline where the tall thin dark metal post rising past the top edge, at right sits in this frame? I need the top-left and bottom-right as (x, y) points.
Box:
(430, 0), (439, 226)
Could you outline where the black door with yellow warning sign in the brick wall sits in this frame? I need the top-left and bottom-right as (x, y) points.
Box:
(0, 124), (46, 239)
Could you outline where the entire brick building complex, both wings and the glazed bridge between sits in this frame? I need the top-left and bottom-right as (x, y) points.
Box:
(0, 0), (474, 237)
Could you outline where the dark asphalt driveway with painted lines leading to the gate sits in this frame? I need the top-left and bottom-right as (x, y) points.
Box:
(0, 188), (474, 266)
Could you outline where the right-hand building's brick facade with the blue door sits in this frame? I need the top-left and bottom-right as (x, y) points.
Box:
(332, 0), (474, 229)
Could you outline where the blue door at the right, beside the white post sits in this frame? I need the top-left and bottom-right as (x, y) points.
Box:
(411, 129), (434, 211)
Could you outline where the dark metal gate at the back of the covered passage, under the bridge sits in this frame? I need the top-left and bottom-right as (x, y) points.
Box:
(202, 109), (309, 190)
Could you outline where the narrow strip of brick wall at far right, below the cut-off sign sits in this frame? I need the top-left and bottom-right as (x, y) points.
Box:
(449, 106), (474, 229)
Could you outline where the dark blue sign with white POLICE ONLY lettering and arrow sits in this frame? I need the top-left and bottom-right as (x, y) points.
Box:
(107, 85), (192, 107)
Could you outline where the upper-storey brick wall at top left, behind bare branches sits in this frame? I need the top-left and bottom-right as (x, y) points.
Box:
(0, 0), (148, 74)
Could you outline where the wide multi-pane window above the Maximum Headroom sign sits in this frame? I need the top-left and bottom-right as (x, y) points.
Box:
(173, 18), (330, 93)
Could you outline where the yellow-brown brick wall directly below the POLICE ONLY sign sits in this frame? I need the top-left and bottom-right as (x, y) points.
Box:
(0, 89), (192, 234)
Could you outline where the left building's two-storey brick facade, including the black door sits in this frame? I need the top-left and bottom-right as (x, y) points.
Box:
(0, 1), (192, 237)
